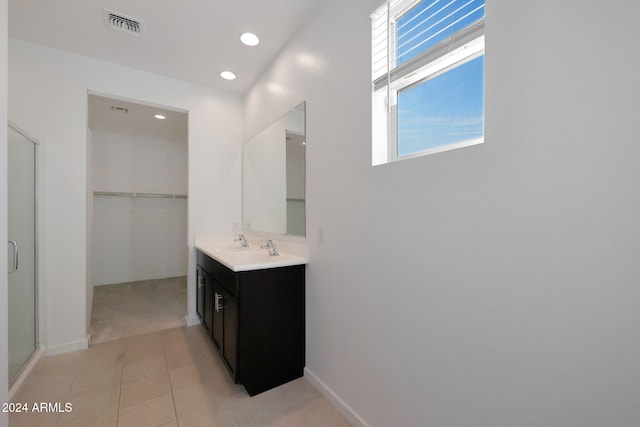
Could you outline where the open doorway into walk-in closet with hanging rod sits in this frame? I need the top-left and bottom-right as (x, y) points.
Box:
(87, 92), (188, 344)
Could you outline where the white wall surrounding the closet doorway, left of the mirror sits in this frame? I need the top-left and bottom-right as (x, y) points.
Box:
(9, 40), (242, 352)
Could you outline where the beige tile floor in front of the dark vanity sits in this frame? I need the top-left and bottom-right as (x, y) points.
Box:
(10, 325), (350, 427)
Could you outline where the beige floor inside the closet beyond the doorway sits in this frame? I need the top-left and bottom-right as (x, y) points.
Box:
(90, 276), (187, 344)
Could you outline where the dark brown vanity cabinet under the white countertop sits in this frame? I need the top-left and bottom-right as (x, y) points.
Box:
(196, 251), (305, 396)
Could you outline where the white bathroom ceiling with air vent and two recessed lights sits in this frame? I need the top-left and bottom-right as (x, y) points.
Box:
(9, 0), (322, 93)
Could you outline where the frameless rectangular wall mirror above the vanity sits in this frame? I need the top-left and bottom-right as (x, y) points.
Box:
(243, 102), (306, 236)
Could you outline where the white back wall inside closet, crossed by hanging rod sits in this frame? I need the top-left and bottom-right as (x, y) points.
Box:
(90, 130), (188, 285)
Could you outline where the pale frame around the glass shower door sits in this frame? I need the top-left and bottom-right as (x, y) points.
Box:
(7, 120), (45, 390)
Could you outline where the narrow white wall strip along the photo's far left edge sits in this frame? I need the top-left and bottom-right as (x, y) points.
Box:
(0, 0), (9, 427)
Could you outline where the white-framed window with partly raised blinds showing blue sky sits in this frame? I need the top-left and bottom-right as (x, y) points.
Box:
(371, 0), (485, 165)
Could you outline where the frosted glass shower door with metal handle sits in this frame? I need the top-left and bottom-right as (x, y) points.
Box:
(7, 126), (38, 383)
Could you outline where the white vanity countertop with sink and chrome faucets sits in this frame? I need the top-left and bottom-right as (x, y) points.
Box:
(195, 239), (308, 271)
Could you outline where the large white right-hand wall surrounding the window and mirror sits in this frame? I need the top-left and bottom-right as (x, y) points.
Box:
(244, 0), (640, 427)
